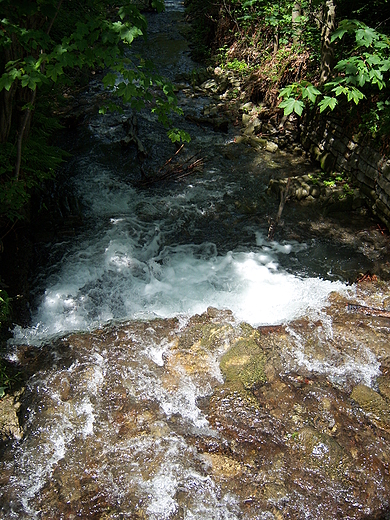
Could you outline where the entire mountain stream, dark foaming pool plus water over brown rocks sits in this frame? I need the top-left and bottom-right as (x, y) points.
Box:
(0, 1), (390, 520)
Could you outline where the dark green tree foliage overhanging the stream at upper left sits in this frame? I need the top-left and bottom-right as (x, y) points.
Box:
(0, 0), (188, 220)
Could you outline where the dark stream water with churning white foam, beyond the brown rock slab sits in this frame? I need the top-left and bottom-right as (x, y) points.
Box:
(9, 2), (350, 343)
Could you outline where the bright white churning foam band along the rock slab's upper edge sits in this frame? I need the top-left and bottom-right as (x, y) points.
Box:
(14, 243), (345, 344)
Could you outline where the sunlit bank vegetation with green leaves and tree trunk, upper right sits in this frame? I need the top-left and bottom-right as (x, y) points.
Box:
(187, 0), (390, 152)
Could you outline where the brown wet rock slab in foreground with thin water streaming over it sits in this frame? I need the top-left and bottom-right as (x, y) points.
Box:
(0, 282), (390, 520)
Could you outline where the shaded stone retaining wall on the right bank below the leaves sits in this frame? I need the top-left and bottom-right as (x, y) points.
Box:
(301, 114), (390, 229)
